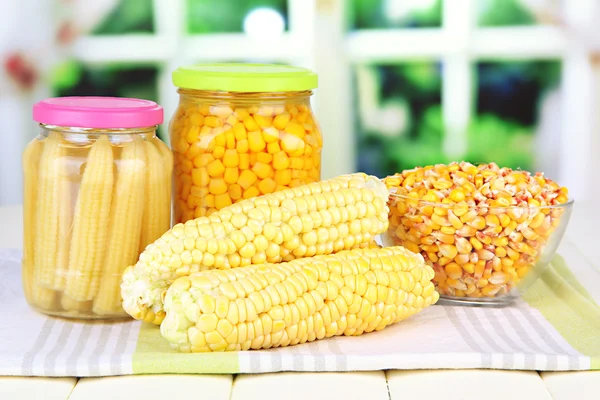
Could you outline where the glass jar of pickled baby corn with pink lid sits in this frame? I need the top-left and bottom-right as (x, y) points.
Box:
(22, 97), (173, 319)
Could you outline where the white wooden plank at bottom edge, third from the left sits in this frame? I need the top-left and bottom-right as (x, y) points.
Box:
(231, 371), (388, 400)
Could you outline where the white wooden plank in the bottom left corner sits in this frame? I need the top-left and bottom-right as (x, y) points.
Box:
(0, 376), (77, 400)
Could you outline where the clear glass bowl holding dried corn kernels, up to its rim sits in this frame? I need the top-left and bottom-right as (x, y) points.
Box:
(381, 193), (573, 307)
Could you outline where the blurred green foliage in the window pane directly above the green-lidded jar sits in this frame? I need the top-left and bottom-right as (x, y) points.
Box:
(187, 0), (287, 33)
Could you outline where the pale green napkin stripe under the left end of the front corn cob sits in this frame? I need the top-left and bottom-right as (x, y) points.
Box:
(133, 323), (240, 374)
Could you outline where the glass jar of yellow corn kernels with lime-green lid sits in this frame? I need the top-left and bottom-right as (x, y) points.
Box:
(169, 64), (323, 223)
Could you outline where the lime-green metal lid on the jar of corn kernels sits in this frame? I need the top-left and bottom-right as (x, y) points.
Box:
(172, 63), (318, 92)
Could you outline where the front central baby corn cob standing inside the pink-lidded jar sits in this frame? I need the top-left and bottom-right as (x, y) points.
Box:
(65, 135), (114, 301)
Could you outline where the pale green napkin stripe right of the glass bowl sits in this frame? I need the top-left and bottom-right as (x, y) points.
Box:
(522, 256), (600, 369)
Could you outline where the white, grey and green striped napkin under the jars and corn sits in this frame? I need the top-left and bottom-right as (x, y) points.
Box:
(0, 239), (600, 377)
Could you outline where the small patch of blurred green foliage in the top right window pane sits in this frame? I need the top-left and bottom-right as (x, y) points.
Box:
(477, 0), (536, 26)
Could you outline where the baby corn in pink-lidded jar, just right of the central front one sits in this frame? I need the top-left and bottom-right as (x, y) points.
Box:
(93, 137), (147, 315)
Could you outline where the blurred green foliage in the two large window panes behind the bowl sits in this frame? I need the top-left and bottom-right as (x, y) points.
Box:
(356, 57), (560, 176)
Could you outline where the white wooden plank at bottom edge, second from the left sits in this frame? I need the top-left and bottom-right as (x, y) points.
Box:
(69, 375), (233, 400)
